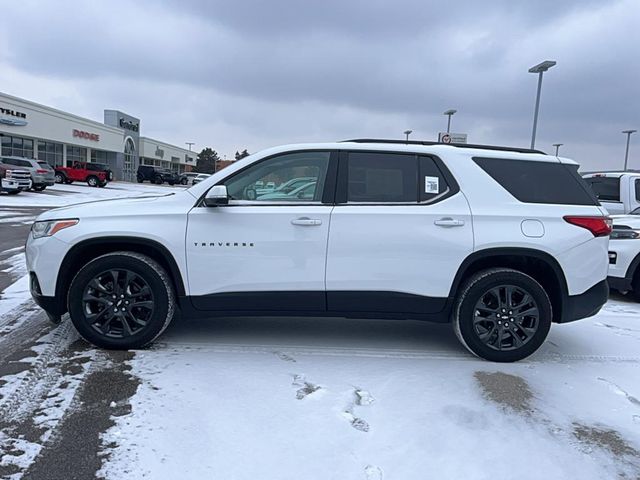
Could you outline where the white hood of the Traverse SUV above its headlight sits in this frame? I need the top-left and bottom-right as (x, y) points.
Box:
(36, 190), (196, 221)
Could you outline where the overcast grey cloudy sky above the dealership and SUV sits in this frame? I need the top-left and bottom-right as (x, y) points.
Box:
(0, 0), (640, 169)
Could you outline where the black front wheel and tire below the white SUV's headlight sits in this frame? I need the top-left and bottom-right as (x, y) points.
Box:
(67, 252), (175, 350)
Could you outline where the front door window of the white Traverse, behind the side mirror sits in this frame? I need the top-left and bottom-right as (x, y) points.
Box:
(224, 152), (331, 203)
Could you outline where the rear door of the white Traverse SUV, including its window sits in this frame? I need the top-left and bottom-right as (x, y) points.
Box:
(326, 152), (473, 313)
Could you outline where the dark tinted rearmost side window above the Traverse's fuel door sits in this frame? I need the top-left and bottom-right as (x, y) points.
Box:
(473, 157), (598, 205)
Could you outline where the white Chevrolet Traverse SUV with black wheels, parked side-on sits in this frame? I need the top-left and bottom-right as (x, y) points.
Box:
(27, 140), (611, 361)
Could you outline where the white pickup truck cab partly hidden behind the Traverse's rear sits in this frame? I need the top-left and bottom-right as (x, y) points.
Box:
(582, 172), (640, 215)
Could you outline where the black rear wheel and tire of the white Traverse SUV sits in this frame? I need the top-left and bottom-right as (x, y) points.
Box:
(453, 268), (552, 362)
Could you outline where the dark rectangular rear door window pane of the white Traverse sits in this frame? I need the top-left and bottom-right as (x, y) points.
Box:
(347, 152), (418, 203)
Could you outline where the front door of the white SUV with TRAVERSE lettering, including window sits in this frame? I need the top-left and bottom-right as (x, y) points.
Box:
(186, 151), (337, 313)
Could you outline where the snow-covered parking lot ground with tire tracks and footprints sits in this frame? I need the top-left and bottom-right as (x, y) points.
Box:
(0, 185), (640, 480)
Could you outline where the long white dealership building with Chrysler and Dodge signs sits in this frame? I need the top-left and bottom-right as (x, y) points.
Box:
(0, 92), (196, 181)
